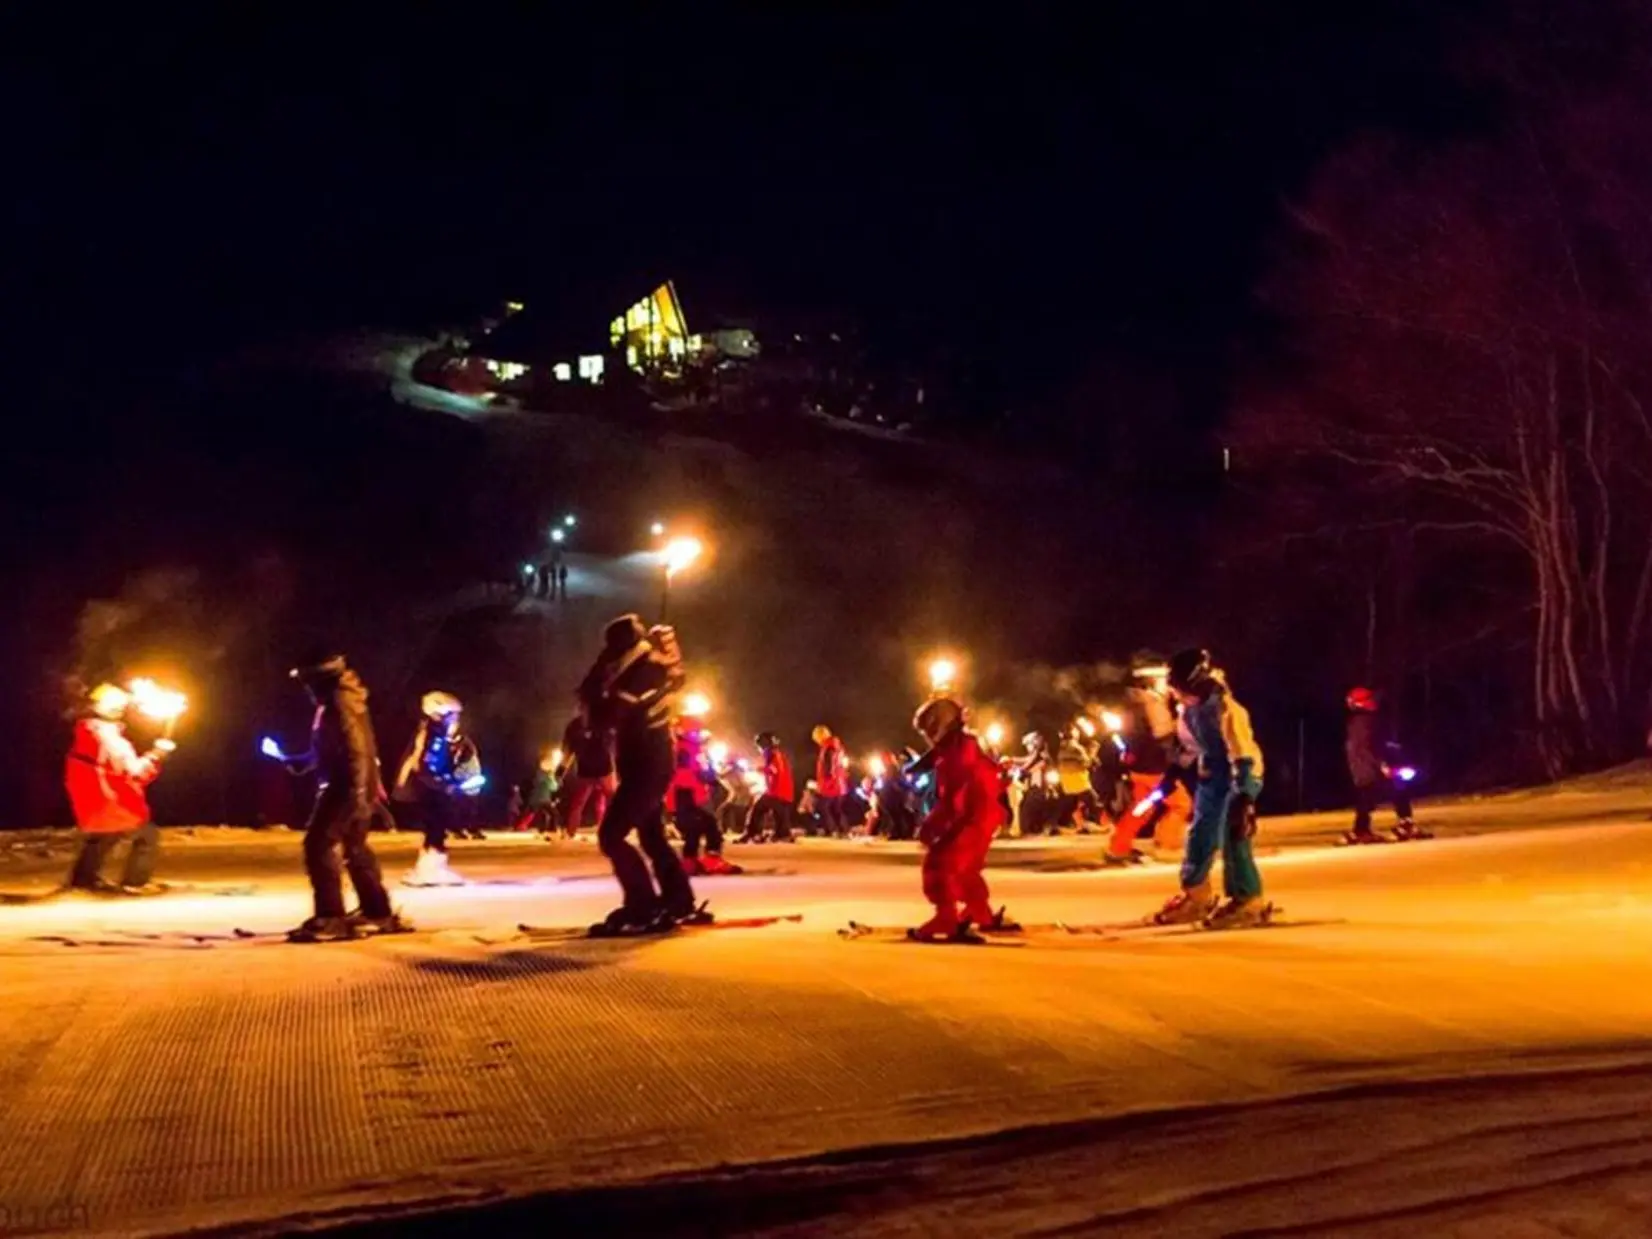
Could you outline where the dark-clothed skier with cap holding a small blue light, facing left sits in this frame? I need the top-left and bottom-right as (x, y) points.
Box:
(282, 653), (413, 942)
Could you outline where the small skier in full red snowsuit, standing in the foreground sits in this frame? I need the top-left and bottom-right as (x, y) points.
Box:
(912, 697), (1004, 942)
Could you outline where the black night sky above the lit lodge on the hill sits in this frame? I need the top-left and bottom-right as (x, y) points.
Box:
(7, 0), (1486, 403)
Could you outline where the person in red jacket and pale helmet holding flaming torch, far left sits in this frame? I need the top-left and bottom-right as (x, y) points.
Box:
(63, 684), (177, 895)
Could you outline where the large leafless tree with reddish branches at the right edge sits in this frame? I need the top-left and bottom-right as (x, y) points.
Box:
(1237, 14), (1652, 775)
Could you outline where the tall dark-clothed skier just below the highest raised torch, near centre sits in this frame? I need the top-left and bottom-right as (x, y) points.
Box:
(580, 615), (709, 937)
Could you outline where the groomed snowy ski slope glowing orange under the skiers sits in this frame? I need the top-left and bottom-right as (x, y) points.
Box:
(0, 773), (1652, 1236)
